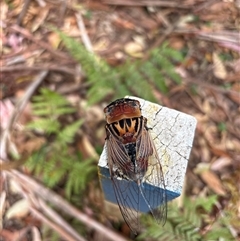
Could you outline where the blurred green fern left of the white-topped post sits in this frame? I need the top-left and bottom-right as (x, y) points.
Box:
(28, 88), (96, 198)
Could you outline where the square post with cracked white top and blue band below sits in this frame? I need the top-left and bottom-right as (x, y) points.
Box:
(98, 96), (197, 212)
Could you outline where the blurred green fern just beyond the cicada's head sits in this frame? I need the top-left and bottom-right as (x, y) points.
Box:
(57, 31), (183, 104)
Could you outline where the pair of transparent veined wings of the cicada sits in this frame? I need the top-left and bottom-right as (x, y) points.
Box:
(107, 123), (167, 233)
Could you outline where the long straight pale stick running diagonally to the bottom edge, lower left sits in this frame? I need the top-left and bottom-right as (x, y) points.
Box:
(6, 170), (126, 241)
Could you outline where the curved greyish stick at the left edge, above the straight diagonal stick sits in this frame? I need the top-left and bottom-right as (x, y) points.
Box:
(0, 71), (48, 159)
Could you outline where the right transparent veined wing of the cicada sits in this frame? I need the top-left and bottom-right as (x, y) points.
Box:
(138, 129), (167, 224)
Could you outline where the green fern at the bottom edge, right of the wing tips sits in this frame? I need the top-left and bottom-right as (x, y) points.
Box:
(138, 195), (235, 241)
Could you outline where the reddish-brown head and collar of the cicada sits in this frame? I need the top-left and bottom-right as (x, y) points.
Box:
(104, 98), (142, 124)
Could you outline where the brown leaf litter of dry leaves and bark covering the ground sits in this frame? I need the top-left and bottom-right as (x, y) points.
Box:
(0, 0), (240, 240)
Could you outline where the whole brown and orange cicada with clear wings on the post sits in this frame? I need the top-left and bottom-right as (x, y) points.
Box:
(104, 98), (167, 233)
